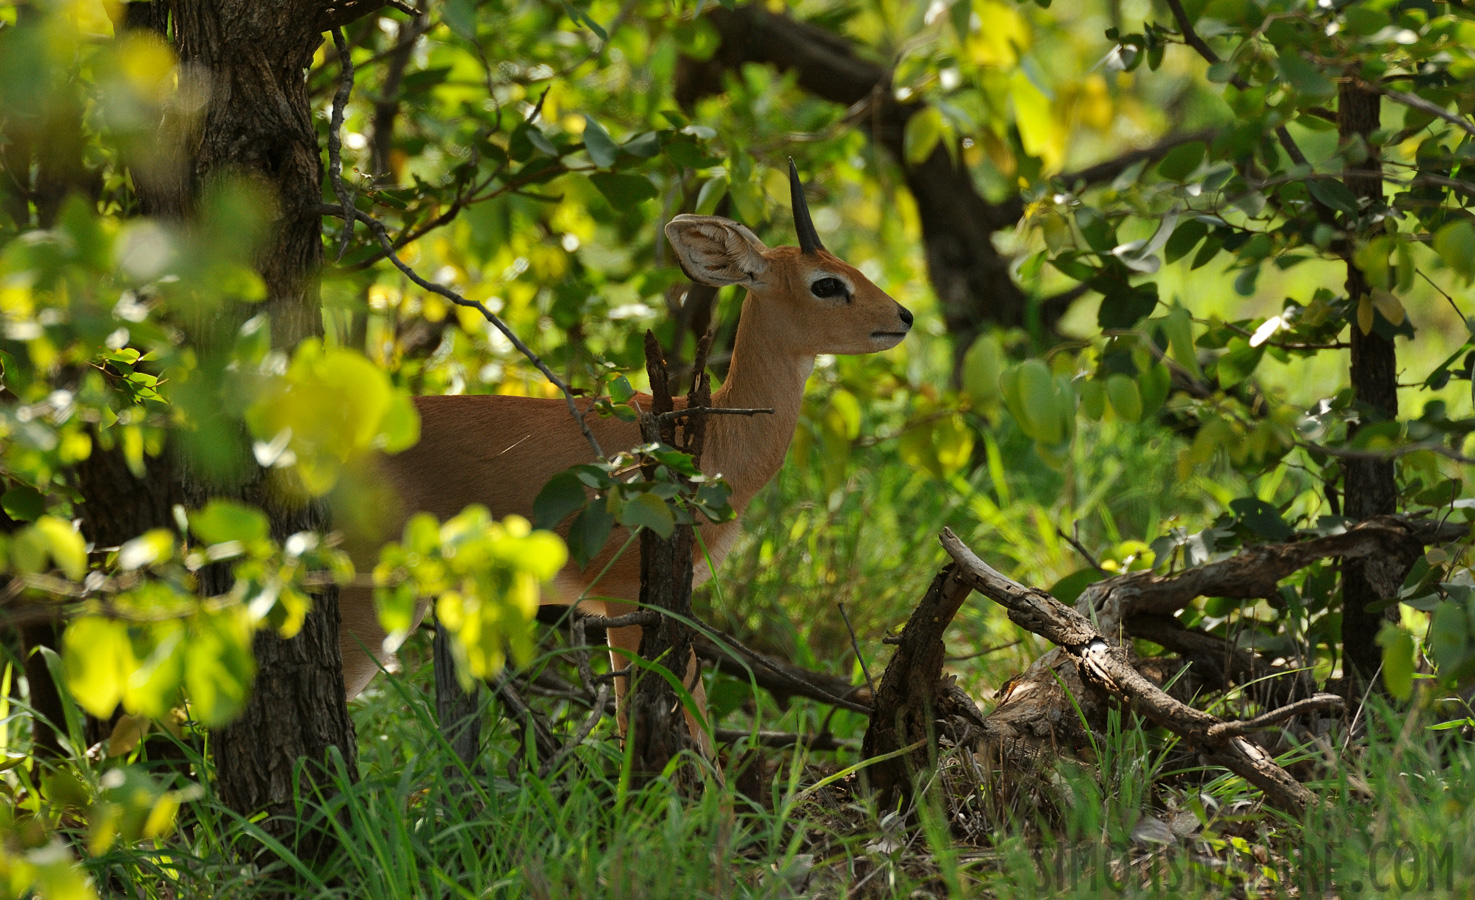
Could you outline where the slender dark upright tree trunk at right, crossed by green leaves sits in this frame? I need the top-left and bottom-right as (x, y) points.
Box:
(1338, 83), (1401, 680)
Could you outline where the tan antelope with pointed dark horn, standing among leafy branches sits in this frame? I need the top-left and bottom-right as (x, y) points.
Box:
(339, 161), (912, 754)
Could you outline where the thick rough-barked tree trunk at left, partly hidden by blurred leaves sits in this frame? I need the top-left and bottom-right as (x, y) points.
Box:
(124, 0), (357, 838)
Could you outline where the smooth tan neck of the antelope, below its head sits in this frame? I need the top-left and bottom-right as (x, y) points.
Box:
(702, 294), (814, 513)
